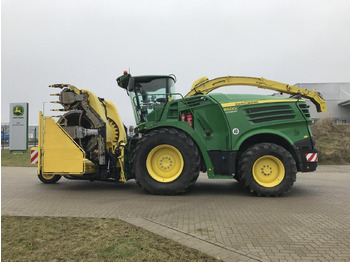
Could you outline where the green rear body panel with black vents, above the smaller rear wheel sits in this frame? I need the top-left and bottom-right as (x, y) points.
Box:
(211, 94), (310, 150)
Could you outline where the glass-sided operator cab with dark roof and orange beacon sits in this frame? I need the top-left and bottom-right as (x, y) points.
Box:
(117, 72), (176, 124)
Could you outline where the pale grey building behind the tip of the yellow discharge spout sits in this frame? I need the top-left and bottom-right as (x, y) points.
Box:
(295, 83), (350, 123)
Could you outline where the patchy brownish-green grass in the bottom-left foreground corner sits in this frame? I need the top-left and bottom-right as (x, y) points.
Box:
(1, 216), (220, 262)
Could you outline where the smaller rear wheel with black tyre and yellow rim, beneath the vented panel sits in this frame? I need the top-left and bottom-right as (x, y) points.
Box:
(239, 143), (297, 196)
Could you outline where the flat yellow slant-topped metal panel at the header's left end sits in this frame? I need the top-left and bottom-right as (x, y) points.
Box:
(43, 118), (85, 174)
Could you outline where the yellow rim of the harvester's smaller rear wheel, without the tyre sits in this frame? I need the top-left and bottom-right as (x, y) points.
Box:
(253, 155), (285, 187)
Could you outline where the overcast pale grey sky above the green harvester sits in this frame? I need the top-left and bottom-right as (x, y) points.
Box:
(1, 0), (350, 126)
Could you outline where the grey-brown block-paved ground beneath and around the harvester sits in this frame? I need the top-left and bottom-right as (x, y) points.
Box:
(1, 165), (350, 261)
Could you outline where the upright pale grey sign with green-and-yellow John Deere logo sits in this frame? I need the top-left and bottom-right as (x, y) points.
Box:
(10, 103), (28, 151)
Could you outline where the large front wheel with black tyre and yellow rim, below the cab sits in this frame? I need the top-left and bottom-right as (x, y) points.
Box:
(132, 128), (200, 195)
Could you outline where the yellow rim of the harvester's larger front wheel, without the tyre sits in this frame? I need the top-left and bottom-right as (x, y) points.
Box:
(146, 145), (184, 183)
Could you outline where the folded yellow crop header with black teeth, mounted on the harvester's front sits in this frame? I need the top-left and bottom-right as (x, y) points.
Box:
(38, 85), (126, 180)
